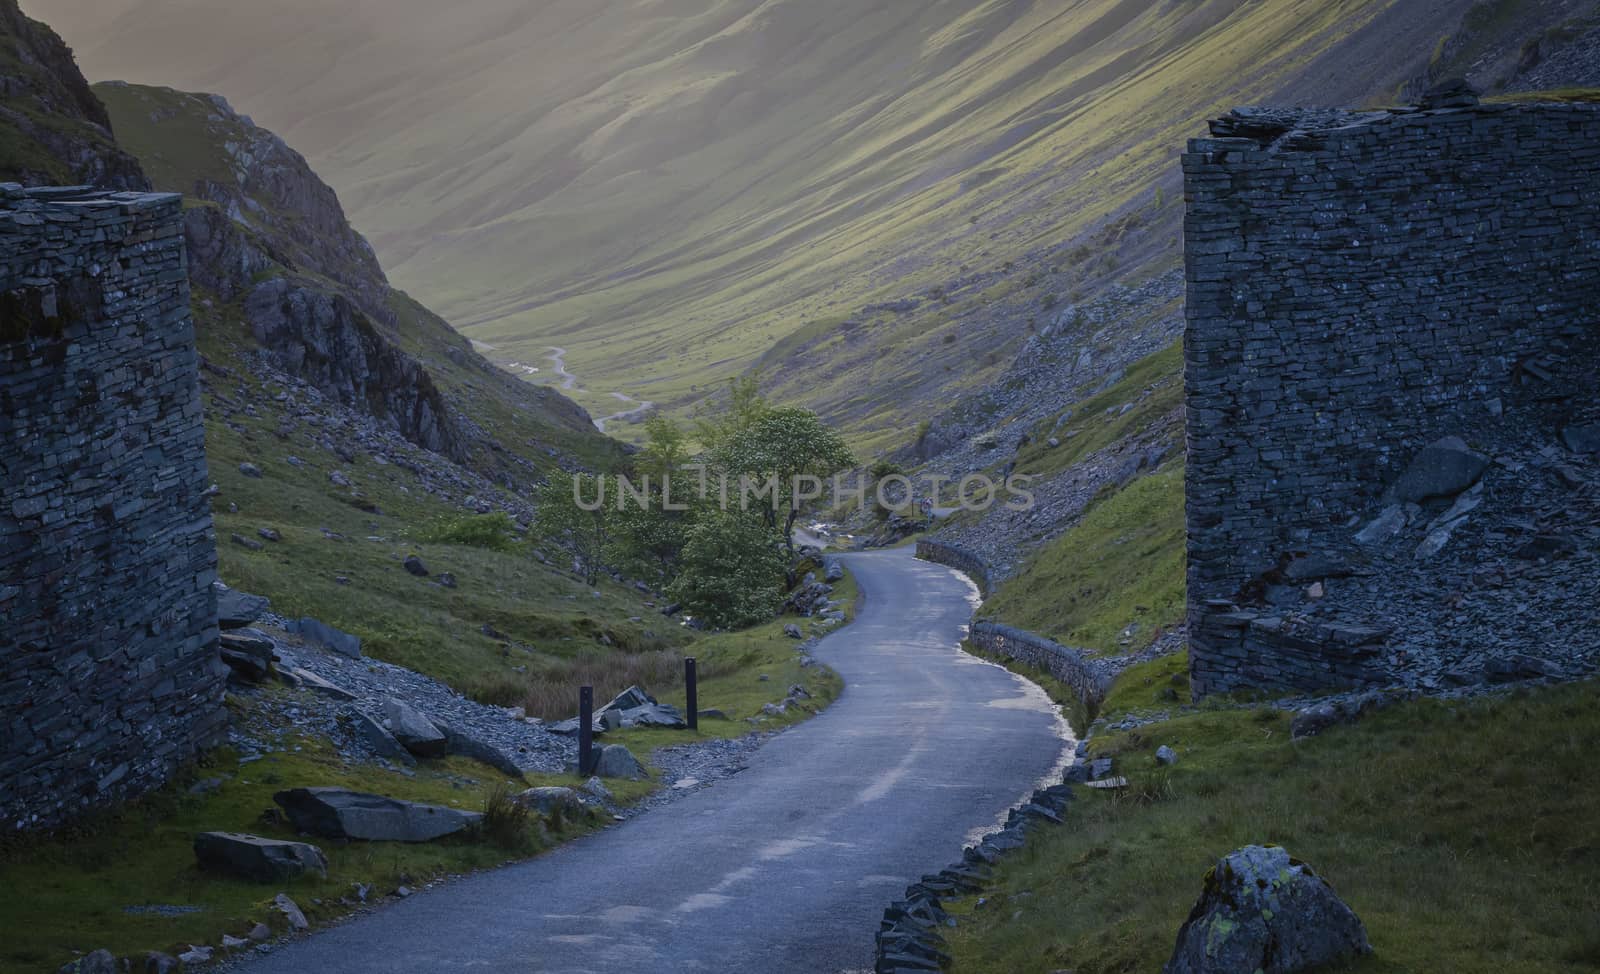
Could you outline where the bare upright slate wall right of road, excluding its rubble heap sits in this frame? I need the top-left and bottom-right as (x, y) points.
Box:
(1184, 98), (1600, 694)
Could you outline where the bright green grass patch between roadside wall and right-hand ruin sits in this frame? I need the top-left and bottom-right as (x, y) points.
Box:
(979, 462), (1186, 653)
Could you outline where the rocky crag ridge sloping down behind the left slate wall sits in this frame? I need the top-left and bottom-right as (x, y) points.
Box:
(96, 83), (614, 476)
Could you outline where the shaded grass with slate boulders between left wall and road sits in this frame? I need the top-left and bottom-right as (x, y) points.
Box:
(0, 729), (636, 974)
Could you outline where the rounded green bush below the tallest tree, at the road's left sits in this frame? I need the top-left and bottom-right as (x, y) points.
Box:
(667, 510), (786, 629)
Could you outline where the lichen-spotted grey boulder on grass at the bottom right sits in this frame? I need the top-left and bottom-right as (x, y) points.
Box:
(1162, 846), (1373, 974)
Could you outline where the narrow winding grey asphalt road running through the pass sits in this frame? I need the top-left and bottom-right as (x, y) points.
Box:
(248, 549), (1067, 974)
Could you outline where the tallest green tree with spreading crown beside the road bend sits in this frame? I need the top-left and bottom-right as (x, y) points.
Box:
(712, 406), (856, 560)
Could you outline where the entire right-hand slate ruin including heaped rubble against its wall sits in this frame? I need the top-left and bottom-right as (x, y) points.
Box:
(1184, 88), (1600, 696)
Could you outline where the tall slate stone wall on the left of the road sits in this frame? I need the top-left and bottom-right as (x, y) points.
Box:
(0, 184), (226, 832)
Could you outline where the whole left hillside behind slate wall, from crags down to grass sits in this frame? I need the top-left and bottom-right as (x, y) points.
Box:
(0, 7), (668, 696)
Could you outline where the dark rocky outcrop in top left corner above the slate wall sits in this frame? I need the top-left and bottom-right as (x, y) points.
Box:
(0, 0), (150, 192)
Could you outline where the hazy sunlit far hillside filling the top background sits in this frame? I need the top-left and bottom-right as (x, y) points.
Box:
(38, 0), (1467, 445)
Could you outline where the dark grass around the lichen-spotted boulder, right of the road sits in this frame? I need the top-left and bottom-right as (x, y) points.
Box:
(946, 681), (1600, 974)
